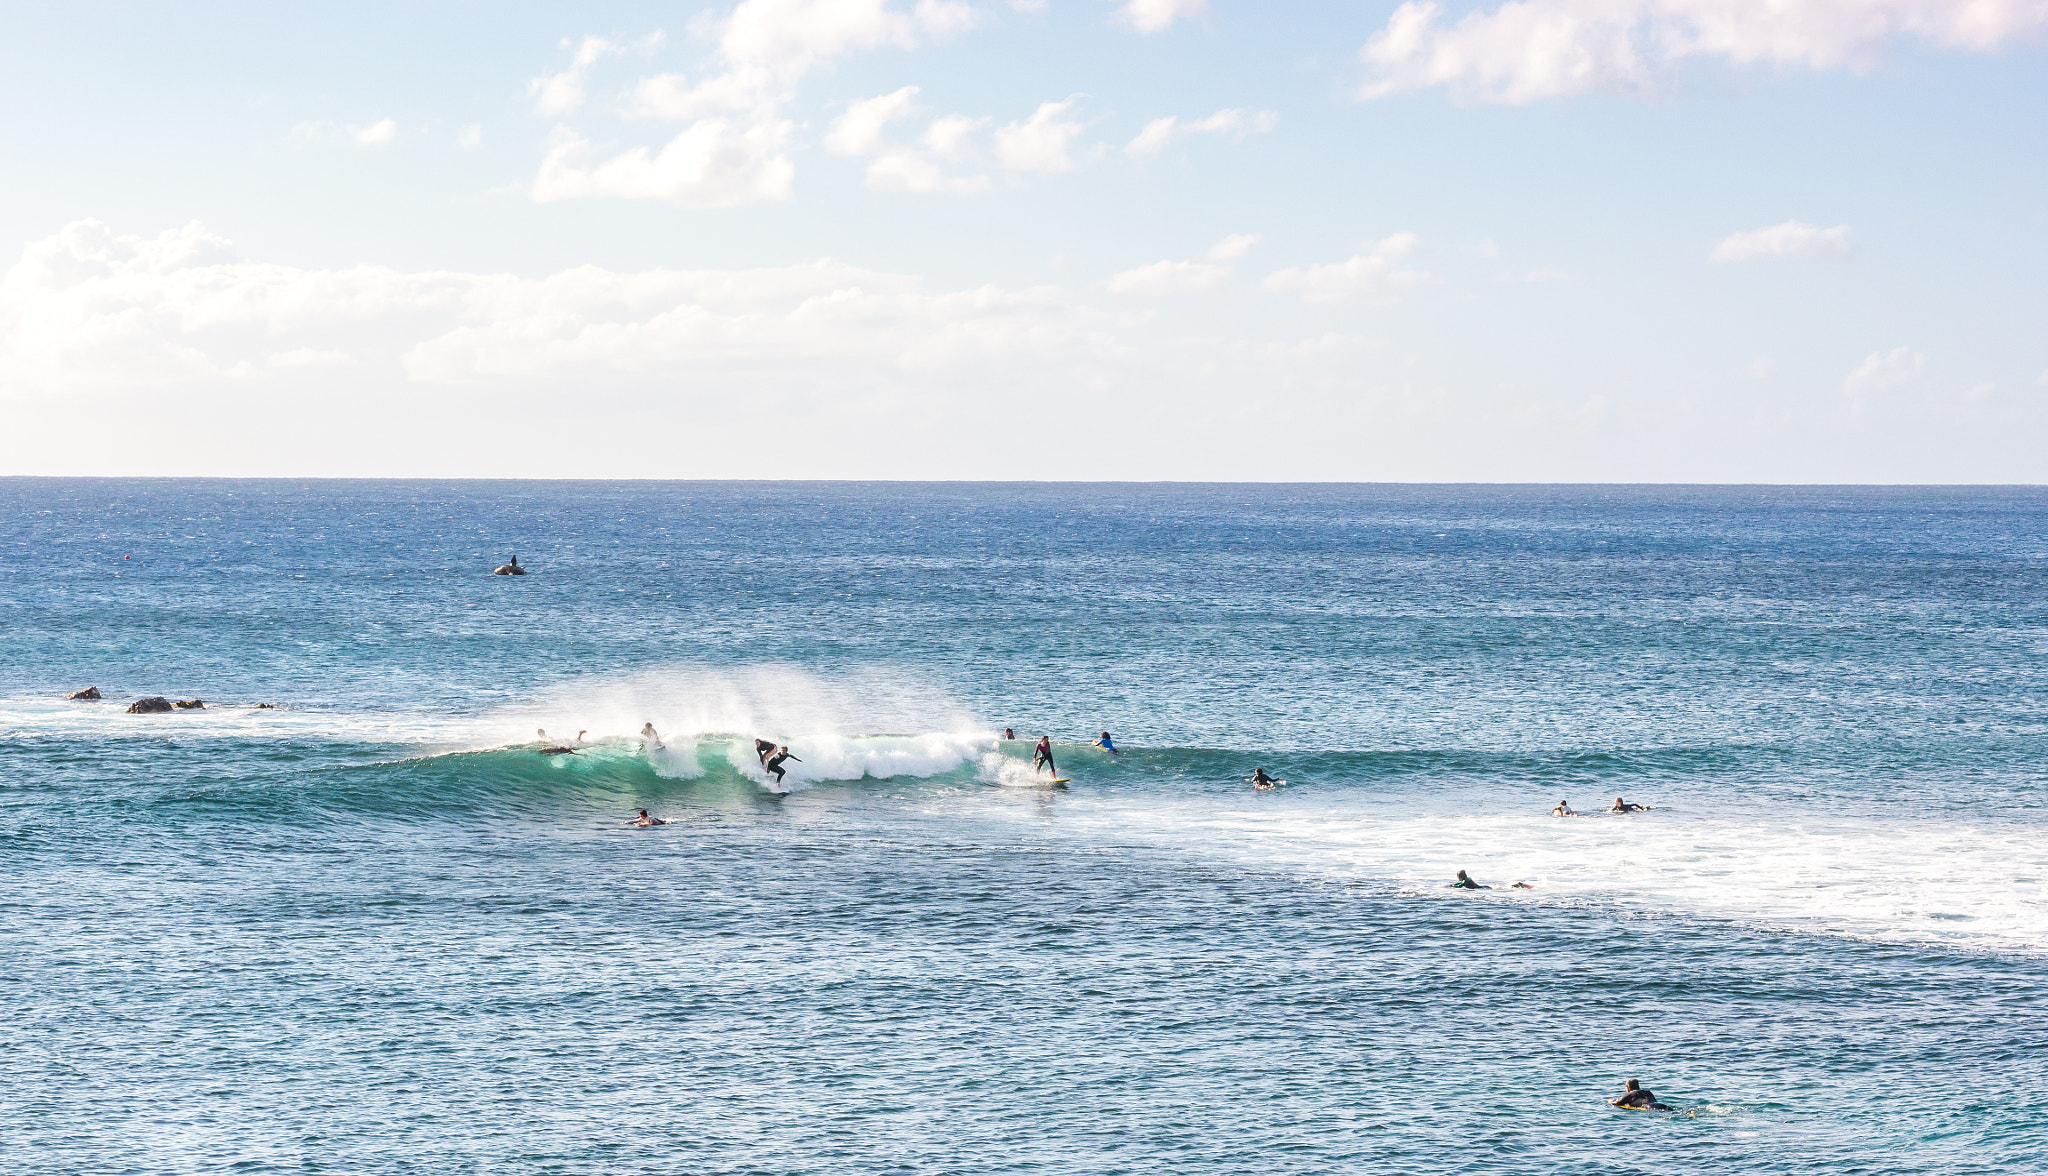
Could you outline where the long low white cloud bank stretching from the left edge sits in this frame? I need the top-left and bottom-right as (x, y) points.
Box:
(0, 221), (1110, 395)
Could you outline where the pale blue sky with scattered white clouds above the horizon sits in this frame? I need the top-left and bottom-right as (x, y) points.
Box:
(0, 0), (2048, 484)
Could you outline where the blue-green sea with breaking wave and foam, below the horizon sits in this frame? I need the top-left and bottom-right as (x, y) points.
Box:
(0, 479), (2048, 1174)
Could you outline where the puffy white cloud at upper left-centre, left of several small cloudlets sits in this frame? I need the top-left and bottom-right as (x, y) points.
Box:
(532, 119), (797, 209)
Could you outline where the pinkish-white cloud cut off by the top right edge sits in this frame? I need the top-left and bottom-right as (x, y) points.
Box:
(1358, 0), (2048, 102)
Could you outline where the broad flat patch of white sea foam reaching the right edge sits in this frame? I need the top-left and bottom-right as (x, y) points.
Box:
(1032, 793), (2048, 955)
